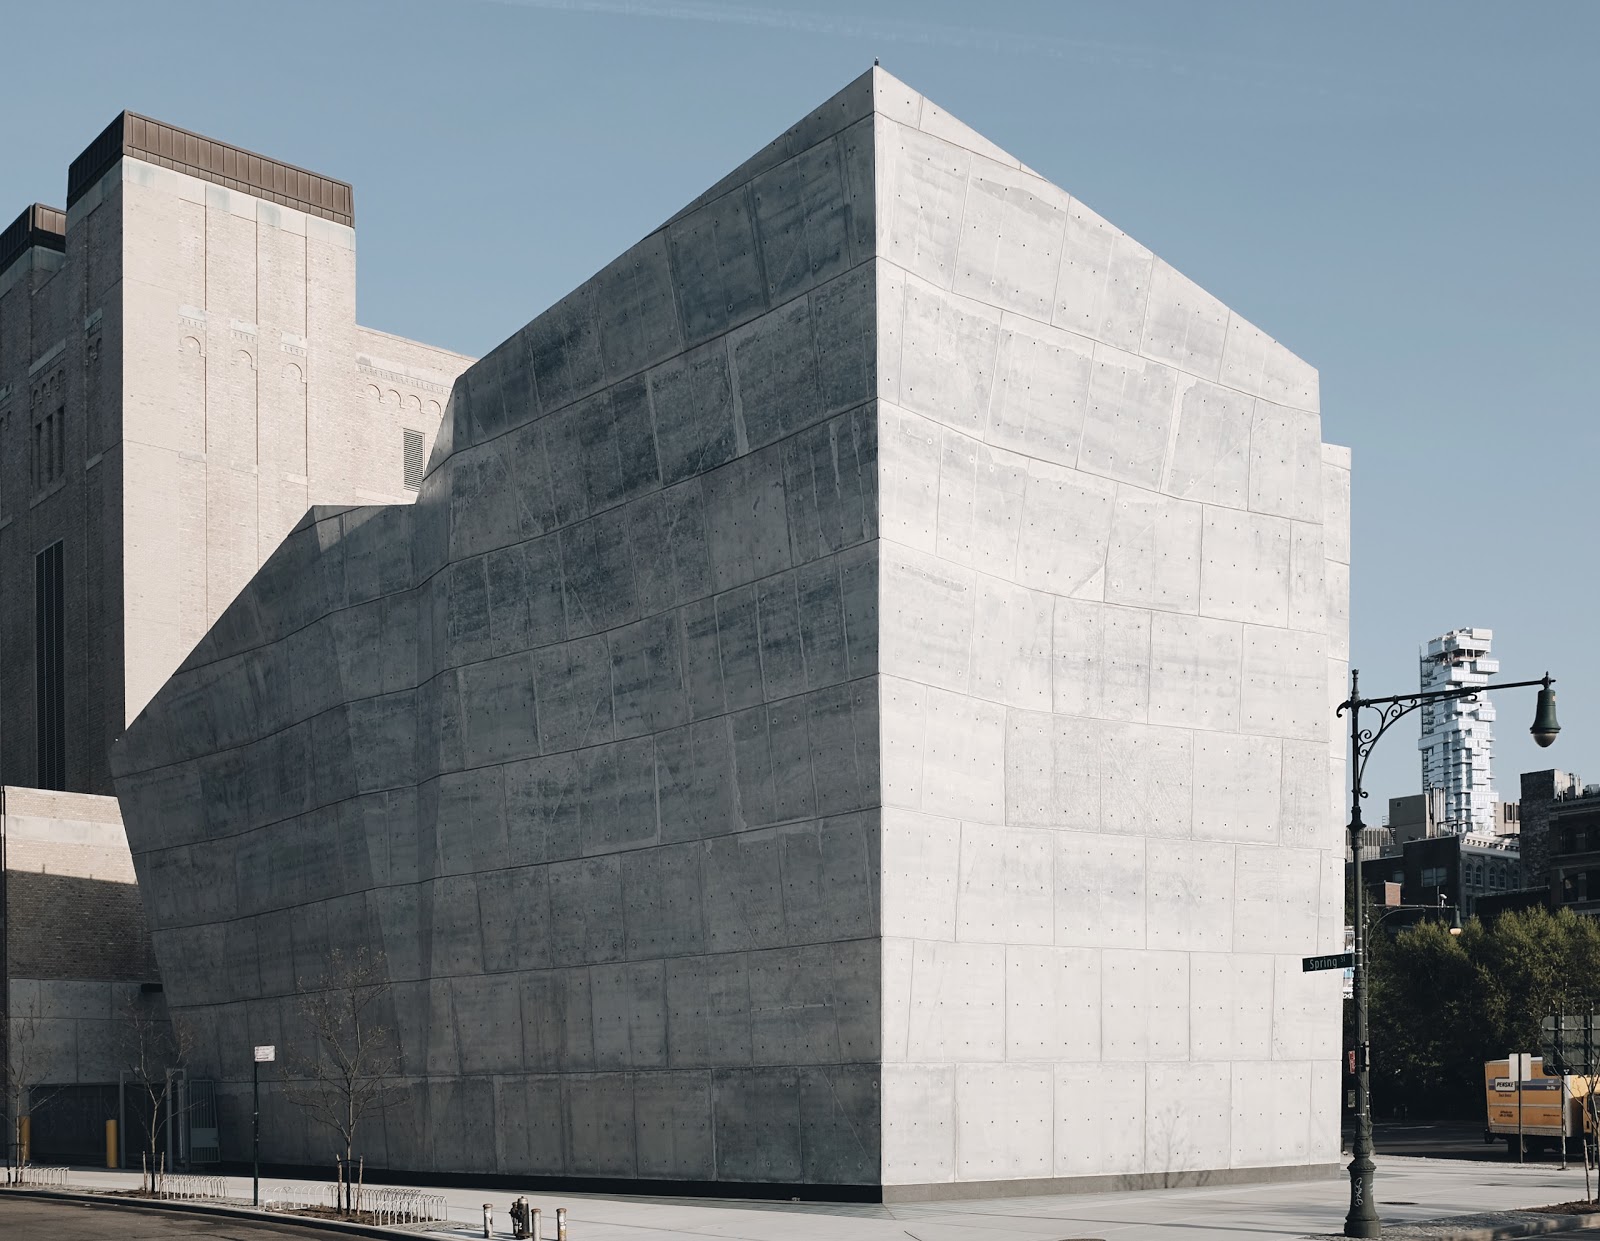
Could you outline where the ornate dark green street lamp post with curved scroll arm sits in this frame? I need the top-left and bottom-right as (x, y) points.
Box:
(1336, 668), (1562, 1236)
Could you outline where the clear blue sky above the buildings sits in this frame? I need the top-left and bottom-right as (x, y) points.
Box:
(0, 0), (1600, 822)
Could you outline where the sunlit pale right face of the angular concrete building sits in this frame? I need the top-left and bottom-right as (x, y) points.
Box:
(875, 72), (1349, 1187)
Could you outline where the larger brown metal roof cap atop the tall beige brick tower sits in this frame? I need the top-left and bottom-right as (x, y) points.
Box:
(67, 112), (355, 227)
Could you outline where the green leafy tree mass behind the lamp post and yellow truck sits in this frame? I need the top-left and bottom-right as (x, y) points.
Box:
(1347, 910), (1600, 1116)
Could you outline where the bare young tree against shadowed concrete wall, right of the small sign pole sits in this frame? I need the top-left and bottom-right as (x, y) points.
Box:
(283, 947), (400, 1212)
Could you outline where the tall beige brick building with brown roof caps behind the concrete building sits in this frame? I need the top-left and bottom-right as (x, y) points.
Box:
(0, 112), (470, 793)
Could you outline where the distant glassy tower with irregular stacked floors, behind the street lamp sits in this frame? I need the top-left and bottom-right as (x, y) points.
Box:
(1418, 628), (1499, 835)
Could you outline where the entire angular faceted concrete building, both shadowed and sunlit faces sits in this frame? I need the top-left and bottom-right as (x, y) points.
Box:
(114, 70), (1349, 1196)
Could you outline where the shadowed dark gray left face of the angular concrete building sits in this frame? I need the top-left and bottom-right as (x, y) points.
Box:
(120, 82), (880, 1183)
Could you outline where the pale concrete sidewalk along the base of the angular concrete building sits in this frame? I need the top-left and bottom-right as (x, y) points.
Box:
(12, 1156), (1584, 1241)
